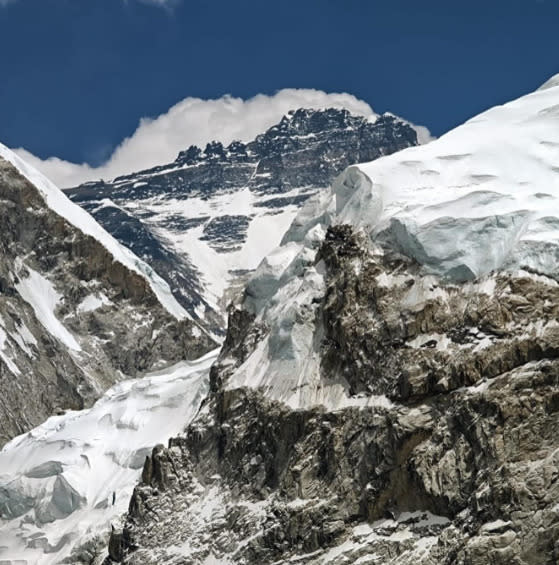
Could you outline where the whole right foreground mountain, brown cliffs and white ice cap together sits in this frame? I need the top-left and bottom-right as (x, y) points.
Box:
(105, 77), (559, 565)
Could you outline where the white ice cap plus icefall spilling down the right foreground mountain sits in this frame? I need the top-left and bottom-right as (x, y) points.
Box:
(227, 77), (559, 409)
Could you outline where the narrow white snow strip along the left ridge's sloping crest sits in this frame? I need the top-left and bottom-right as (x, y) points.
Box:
(0, 143), (190, 319)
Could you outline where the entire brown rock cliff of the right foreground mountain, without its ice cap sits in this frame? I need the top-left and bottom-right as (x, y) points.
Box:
(107, 226), (559, 565)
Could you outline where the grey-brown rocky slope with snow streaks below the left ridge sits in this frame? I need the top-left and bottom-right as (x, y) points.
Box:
(0, 160), (213, 445)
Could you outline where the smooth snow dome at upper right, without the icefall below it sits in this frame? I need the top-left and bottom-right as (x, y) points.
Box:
(336, 77), (559, 280)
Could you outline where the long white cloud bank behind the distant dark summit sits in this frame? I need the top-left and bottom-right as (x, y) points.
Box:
(13, 88), (374, 188)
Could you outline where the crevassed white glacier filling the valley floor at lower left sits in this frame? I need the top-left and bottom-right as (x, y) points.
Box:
(0, 351), (217, 565)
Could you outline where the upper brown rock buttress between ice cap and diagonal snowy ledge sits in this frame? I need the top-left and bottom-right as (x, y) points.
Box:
(320, 226), (559, 402)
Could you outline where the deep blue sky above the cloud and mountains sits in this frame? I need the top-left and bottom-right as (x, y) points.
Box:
(0, 0), (559, 185)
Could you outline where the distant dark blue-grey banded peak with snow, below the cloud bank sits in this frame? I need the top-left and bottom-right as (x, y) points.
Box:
(67, 108), (417, 333)
